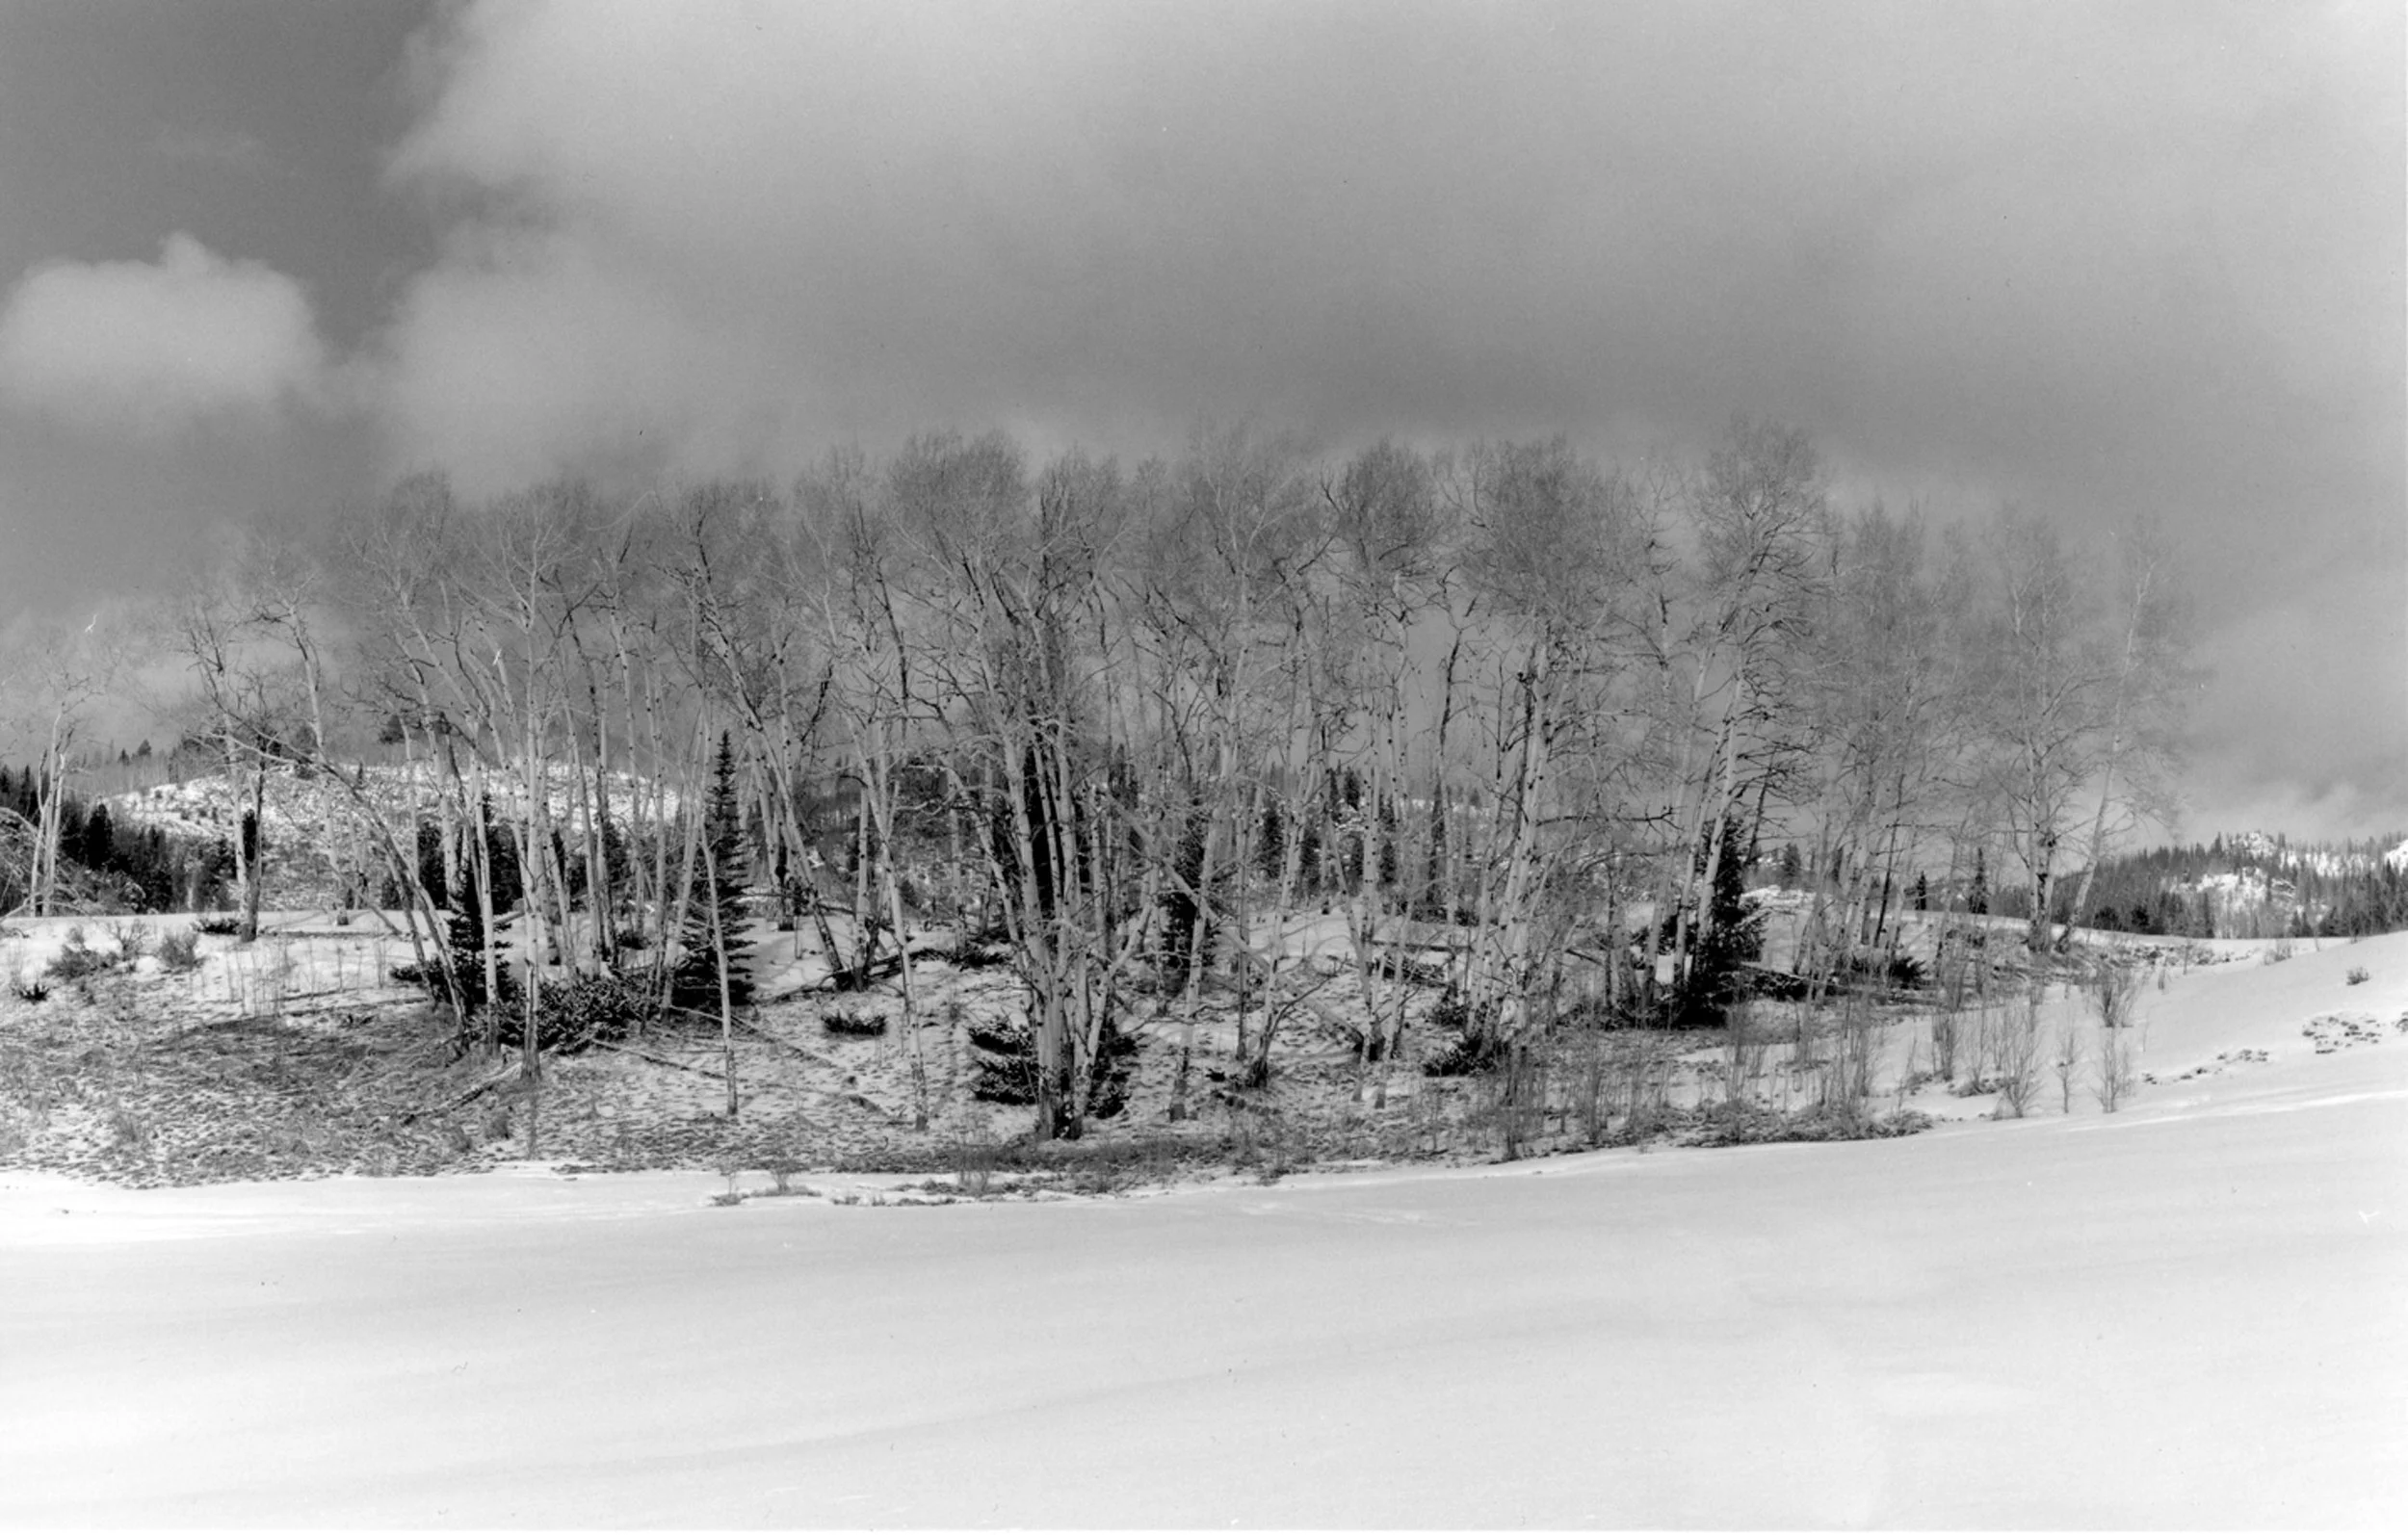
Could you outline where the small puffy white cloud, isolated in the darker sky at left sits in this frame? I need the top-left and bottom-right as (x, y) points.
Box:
(0, 233), (330, 435)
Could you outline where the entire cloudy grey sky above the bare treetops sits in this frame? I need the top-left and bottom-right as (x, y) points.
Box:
(0, 0), (2408, 837)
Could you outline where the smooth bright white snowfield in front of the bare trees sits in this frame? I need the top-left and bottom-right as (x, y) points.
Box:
(13, 936), (2408, 1528)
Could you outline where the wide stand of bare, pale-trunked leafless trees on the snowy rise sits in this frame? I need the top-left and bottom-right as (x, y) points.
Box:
(0, 421), (2191, 1135)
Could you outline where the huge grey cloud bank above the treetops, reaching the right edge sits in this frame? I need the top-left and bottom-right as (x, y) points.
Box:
(395, 5), (2401, 519)
